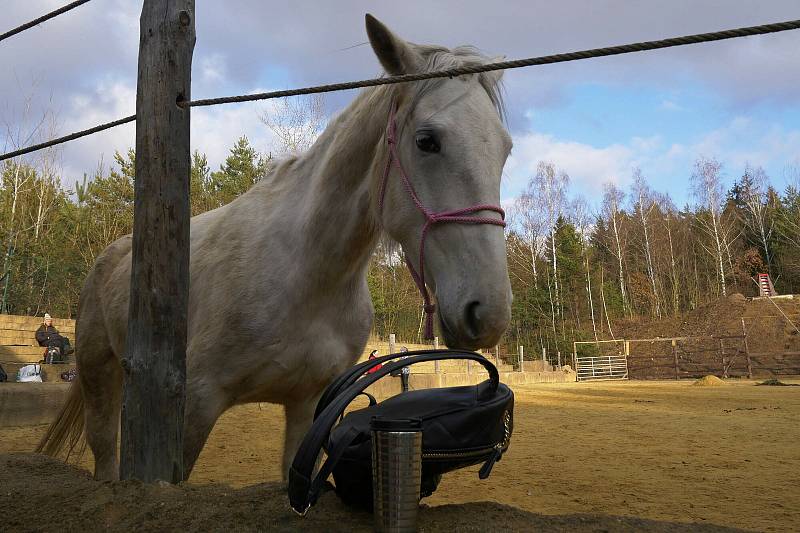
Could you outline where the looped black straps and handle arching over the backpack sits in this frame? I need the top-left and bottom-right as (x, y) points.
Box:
(289, 350), (500, 515)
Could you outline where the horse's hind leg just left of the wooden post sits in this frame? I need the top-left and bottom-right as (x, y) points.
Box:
(78, 349), (122, 481)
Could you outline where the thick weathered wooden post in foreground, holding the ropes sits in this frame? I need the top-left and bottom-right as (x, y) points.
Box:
(120, 0), (195, 483)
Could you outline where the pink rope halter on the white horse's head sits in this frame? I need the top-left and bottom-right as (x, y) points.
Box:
(378, 103), (506, 339)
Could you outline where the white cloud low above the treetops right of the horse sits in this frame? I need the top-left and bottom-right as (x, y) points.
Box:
(503, 115), (800, 206)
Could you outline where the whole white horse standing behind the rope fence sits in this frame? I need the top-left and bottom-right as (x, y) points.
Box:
(39, 15), (511, 480)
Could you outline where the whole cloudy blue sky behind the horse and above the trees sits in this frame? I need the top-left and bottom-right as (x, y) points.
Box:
(0, 0), (800, 212)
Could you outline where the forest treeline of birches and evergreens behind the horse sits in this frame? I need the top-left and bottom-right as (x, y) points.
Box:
(0, 137), (800, 353)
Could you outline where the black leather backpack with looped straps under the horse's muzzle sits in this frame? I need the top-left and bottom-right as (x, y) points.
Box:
(289, 350), (514, 514)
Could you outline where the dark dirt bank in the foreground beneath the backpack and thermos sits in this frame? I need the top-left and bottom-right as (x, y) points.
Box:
(0, 454), (736, 532)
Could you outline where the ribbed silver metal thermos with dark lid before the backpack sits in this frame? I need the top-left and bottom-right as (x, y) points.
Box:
(371, 417), (422, 532)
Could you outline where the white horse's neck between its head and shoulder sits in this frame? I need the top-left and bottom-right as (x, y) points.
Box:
(284, 87), (391, 284)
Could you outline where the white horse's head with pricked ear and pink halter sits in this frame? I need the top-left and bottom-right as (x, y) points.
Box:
(367, 15), (511, 349)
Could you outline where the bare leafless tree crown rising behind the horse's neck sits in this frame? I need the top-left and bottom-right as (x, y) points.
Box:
(259, 94), (325, 154)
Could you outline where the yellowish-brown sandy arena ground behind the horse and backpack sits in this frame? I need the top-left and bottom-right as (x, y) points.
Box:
(0, 380), (800, 531)
